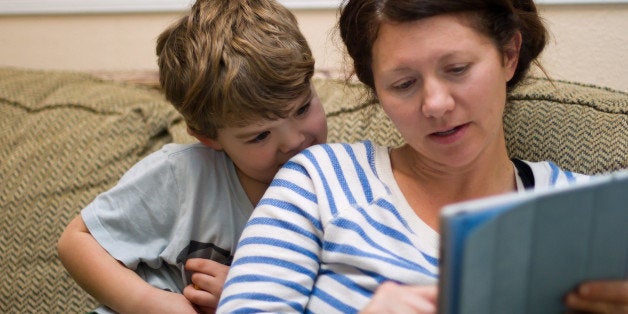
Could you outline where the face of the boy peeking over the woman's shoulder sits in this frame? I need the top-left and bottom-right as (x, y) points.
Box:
(209, 87), (327, 185)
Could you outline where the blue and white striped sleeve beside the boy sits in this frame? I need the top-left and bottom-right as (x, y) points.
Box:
(219, 146), (360, 313)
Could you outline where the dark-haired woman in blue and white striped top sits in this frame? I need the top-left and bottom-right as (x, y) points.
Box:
(219, 0), (628, 312)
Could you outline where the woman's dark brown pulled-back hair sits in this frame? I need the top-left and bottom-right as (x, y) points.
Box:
(338, 0), (548, 90)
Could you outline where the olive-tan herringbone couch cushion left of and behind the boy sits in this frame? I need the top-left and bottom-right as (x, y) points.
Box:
(0, 68), (178, 313)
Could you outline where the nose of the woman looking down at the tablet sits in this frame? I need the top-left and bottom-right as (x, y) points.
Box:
(421, 79), (455, 118)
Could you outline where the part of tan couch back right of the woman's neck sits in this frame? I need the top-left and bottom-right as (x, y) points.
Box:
(504, 79), (628, 174)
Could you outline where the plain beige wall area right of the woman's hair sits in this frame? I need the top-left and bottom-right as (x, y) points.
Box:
(541, 4), (628, 91)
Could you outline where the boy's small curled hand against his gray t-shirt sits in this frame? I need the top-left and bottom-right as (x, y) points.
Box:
(183, 258), (229, 313)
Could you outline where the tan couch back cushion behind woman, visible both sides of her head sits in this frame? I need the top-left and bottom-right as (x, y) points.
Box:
(314, 78), (628, 174)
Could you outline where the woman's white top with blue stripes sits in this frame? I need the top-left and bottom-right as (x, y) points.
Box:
(219, 141), (580, 313)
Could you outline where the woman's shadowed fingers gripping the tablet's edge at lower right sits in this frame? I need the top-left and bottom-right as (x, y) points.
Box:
(565, 280), (628, 313)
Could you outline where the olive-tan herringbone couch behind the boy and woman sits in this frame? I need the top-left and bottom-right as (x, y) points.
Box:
(0, 68), (628, 313)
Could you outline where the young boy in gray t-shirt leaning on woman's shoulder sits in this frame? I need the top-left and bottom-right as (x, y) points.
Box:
(58, 0), (327, 313)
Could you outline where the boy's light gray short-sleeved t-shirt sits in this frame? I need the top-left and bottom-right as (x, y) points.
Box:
(81, 143), (253, 300)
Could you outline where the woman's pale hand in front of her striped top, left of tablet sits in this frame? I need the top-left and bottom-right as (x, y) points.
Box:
(360, 281), (438, 314)
